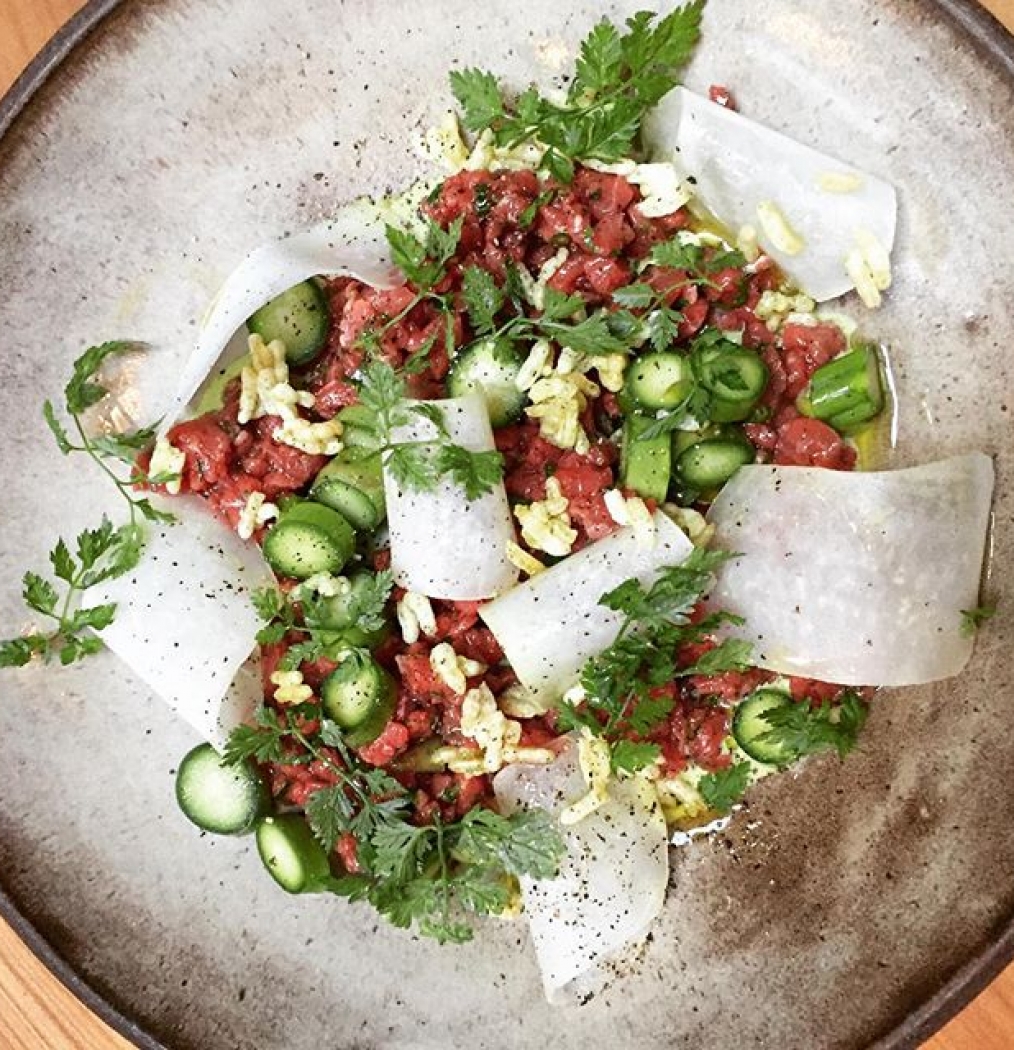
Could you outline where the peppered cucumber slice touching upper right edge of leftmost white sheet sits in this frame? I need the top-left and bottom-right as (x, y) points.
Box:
(263, 503), (356, 580)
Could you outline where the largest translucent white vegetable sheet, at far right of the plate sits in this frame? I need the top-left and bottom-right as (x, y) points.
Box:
(709, 453), (993, 686)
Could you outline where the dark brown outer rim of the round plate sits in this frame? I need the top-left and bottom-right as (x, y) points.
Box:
(0, 0), (1014, 1050)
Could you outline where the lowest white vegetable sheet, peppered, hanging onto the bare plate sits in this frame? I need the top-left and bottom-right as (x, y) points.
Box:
(493, 744), (669, 1003)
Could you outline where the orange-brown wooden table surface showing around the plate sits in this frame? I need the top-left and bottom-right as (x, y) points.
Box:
(0, 0), (1014, 1050)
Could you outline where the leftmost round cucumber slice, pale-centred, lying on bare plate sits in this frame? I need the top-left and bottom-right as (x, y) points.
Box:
(176, 743), (271, 835)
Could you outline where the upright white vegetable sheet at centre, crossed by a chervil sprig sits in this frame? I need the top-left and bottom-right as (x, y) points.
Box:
(384, 394), (517, 601)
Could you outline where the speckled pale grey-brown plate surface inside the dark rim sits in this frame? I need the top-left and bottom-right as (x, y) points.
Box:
(0, 0), (1014, 1050)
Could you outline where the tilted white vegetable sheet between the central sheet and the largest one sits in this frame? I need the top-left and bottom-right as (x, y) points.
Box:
(480, 510), (693, 701)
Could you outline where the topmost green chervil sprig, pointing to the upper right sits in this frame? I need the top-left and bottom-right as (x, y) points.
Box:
(450, 0), (703, 182)
